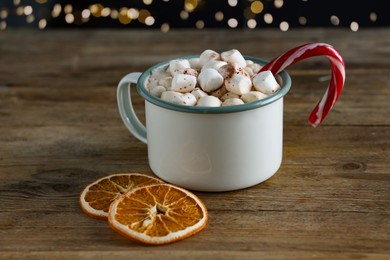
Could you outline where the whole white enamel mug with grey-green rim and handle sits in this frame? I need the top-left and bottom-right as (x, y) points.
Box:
(117, 56), (291, 191)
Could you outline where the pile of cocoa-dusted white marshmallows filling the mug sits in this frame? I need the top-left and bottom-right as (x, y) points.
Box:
(147, 49), (280, 107)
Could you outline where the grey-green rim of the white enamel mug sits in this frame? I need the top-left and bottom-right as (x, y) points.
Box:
(137, 55), (291, 114)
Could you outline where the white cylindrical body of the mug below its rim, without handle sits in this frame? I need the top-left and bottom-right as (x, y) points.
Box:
(145, 98), (283, 191)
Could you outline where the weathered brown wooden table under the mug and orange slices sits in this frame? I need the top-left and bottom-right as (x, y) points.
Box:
(0, 28), (390, 259)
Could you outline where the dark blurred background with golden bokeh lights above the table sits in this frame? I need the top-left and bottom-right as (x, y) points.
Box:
(0, 0), (390, 32)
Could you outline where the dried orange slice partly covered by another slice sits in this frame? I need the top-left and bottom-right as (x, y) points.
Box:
(80, 173), (162, 219)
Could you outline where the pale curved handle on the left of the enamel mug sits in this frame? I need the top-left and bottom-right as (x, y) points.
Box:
(116, 72), (148, 144)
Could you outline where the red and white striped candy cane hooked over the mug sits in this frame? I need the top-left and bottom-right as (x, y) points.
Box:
(259, 43), (345, 127)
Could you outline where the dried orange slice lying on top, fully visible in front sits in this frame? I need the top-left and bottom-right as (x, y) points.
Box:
(108, 183), (208, 245)
